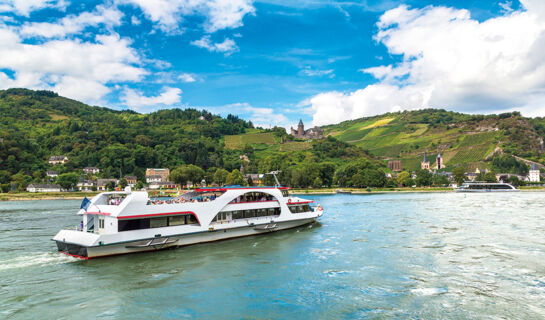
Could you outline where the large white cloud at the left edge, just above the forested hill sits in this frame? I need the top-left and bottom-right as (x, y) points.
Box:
(0, 25), (147, 103)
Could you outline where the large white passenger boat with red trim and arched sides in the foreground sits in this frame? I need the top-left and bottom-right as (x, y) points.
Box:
(52, 186), (323, 259)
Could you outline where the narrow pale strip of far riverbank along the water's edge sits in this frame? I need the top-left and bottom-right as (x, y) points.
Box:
(0, 187), (545, 201)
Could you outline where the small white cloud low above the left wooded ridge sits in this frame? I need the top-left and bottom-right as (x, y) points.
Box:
(122, 87), (182, 110)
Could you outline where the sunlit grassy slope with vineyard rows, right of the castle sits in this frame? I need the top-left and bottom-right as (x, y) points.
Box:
(324, 110), (527, 170)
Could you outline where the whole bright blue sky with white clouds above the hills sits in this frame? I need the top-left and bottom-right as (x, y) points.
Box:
(0, 0), (545, 127)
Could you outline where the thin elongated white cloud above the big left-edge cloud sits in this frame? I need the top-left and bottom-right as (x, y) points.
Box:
(21, 6), (123, 38)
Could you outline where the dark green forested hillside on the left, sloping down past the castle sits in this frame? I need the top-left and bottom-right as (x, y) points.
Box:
(0, 89), (382, 189)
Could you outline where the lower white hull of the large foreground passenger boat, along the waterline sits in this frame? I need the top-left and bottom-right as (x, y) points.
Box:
(55, 217), (317, 259)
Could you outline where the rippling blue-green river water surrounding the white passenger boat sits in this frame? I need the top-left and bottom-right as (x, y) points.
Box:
(0, 192), (545, 319)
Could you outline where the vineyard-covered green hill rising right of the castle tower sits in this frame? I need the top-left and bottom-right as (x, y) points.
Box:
(323, 109), (545, 170)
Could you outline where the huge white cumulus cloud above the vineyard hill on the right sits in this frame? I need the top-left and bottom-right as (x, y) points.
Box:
(308, 0), (545, 125)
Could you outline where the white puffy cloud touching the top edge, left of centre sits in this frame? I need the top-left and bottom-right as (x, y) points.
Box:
(118, 0), (255, 33)
